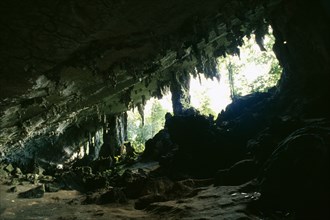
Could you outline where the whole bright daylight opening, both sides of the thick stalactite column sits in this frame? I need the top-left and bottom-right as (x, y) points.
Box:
(128, 25), (282, 152)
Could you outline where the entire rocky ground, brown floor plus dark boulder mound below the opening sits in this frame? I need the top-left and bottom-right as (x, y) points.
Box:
(0, 92), (330, 219)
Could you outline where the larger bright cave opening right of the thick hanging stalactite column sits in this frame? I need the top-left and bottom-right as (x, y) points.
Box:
(190, 27), (282, 116)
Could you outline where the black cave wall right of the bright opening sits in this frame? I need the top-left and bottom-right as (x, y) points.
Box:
(268, 0), (330, 117)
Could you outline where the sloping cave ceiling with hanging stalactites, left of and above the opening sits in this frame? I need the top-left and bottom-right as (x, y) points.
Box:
(0, 0), (275, 162)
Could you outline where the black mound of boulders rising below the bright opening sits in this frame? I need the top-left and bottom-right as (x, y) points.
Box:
(139, 93), (330, 219)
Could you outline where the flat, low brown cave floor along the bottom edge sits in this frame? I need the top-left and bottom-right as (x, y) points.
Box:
(0, 182), (267, 220)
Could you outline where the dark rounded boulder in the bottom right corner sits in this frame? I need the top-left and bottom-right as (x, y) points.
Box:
(259, 123), (330, 219)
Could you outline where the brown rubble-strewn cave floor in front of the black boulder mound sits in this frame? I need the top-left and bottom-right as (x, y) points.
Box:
(0, 160), (257, 219)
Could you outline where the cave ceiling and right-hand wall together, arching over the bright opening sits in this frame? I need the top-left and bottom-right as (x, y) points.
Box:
(0, 0), (330, 165)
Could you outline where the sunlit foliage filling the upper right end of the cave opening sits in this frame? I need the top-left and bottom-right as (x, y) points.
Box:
(218, 26), (282, 97)
